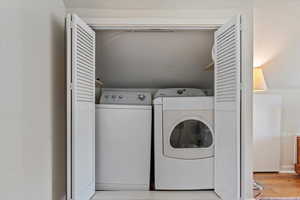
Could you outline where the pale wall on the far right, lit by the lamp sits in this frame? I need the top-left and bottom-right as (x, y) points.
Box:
(254, 0), (300, 171)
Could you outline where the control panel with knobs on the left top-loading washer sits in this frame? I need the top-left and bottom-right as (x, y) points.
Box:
(100, 90), (152, 105)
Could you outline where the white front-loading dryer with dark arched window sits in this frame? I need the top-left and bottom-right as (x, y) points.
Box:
(154, 88), (214, 190)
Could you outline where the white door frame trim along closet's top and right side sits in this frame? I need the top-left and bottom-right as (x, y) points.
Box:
(70, 9), (253, 200)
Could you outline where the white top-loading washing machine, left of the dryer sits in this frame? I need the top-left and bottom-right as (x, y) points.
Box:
(96, 90), (152, 190)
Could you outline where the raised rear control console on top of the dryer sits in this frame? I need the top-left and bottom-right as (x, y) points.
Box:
(154, 88), (206, 98)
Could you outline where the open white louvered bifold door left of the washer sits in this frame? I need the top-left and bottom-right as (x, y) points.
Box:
(67, 15), (95, 200)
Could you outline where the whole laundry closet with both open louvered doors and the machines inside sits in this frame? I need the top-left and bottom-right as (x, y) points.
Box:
(67, 15), (241, 200)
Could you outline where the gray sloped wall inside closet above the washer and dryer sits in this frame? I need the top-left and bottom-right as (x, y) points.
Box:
(96, 30), (214, 88)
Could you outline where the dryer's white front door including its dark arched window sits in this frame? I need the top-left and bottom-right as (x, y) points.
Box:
(163, 111), (214, 160)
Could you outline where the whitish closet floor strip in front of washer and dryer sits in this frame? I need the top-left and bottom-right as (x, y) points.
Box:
(92, 191), (220, 200)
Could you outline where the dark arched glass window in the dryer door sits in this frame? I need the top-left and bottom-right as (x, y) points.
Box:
(170, 119), (213, 149)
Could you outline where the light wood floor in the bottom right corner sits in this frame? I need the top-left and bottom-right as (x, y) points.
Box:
(254, 173), (300, 199)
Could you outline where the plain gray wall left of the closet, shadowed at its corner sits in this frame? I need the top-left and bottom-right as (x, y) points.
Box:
(0, 0), (66, 200)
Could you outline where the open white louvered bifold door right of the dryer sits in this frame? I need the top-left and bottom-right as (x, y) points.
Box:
(215, 16), (241, 200)
